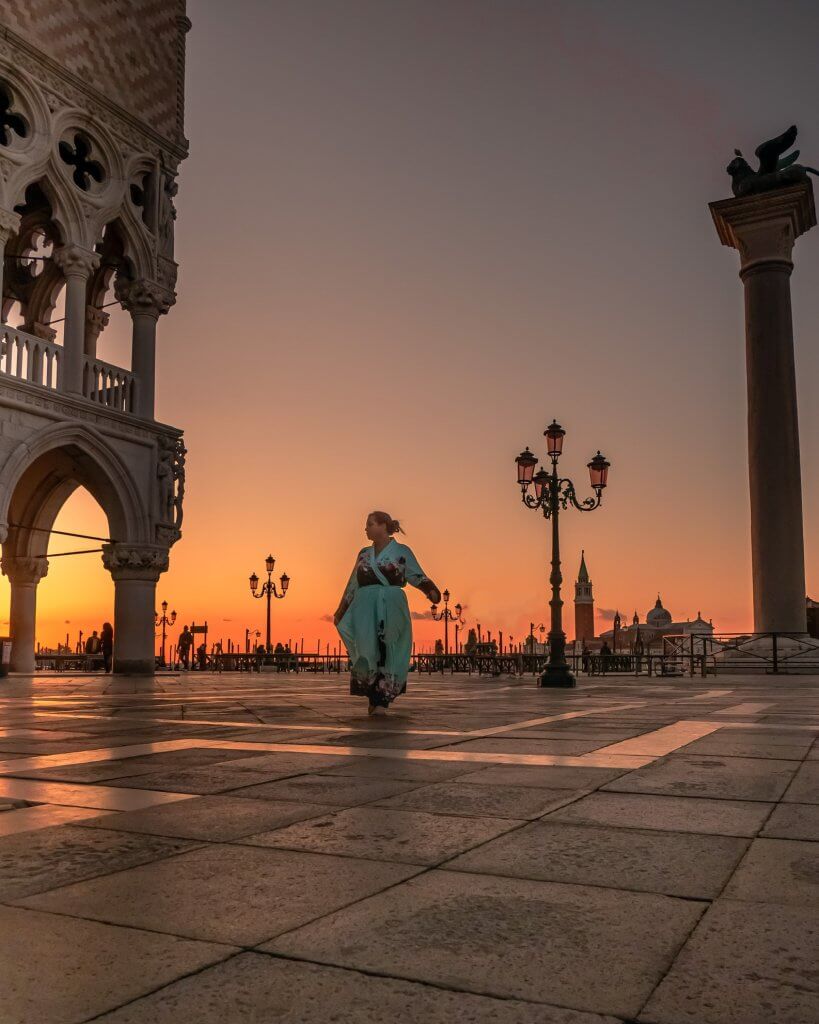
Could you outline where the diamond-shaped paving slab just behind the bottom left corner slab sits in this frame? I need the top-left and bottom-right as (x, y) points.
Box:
(21, 829), (419, 945)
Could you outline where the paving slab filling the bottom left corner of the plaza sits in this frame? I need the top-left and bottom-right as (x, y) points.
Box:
(0, 906), (234, 1024)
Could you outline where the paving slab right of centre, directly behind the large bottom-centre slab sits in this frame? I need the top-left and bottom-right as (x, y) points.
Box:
(446, 819), (748, 899)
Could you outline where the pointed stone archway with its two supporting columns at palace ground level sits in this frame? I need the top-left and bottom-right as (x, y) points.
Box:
(0, 423), (168, 673)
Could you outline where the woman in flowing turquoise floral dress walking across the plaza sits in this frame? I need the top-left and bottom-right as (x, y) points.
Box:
(333, 512), (441, 715)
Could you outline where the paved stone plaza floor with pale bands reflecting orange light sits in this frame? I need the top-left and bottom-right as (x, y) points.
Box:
(0, 674), (819, 1024)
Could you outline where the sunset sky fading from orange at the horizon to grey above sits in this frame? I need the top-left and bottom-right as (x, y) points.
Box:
(20, 0), (819, 647)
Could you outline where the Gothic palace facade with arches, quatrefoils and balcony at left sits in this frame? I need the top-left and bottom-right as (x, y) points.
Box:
(0, 0), (189, 673)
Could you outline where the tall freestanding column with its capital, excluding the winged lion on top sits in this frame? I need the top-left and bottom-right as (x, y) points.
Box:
(710, 182), (816, 633)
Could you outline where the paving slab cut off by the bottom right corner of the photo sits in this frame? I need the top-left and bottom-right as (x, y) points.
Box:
(639, 899), (819, 1024)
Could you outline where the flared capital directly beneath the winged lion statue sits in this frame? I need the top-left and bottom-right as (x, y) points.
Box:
(708, 181), (816, 275)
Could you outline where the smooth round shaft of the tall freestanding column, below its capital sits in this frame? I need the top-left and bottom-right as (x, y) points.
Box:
(741, 260), (807, 633)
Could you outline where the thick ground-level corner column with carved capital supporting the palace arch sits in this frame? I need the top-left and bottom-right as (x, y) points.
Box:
(102, 544), (168, 676)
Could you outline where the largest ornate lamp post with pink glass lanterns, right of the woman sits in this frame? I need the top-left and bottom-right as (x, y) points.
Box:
(515, 420), (610, 686)
